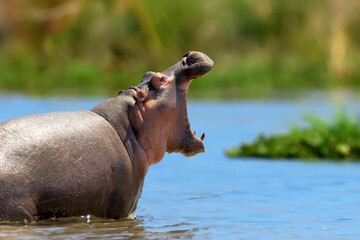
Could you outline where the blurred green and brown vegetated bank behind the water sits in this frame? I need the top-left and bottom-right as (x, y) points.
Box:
(0, 0), (360, 99)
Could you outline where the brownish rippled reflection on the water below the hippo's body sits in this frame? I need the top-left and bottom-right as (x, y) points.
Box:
(0, 217), (202, 239)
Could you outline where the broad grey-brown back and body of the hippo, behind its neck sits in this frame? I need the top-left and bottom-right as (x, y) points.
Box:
(0, 111), (137, 220)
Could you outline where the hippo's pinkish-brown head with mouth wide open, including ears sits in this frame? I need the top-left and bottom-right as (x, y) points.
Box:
(126, 51), (214, 165)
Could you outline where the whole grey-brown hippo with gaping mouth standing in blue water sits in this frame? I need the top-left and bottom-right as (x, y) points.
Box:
(0, 51), (214, 222)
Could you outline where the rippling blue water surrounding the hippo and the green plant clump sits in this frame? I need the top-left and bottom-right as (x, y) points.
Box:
(0, 96), (360, 240)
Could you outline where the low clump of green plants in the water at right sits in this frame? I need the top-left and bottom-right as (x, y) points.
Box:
(226, 113), (360, 161)
